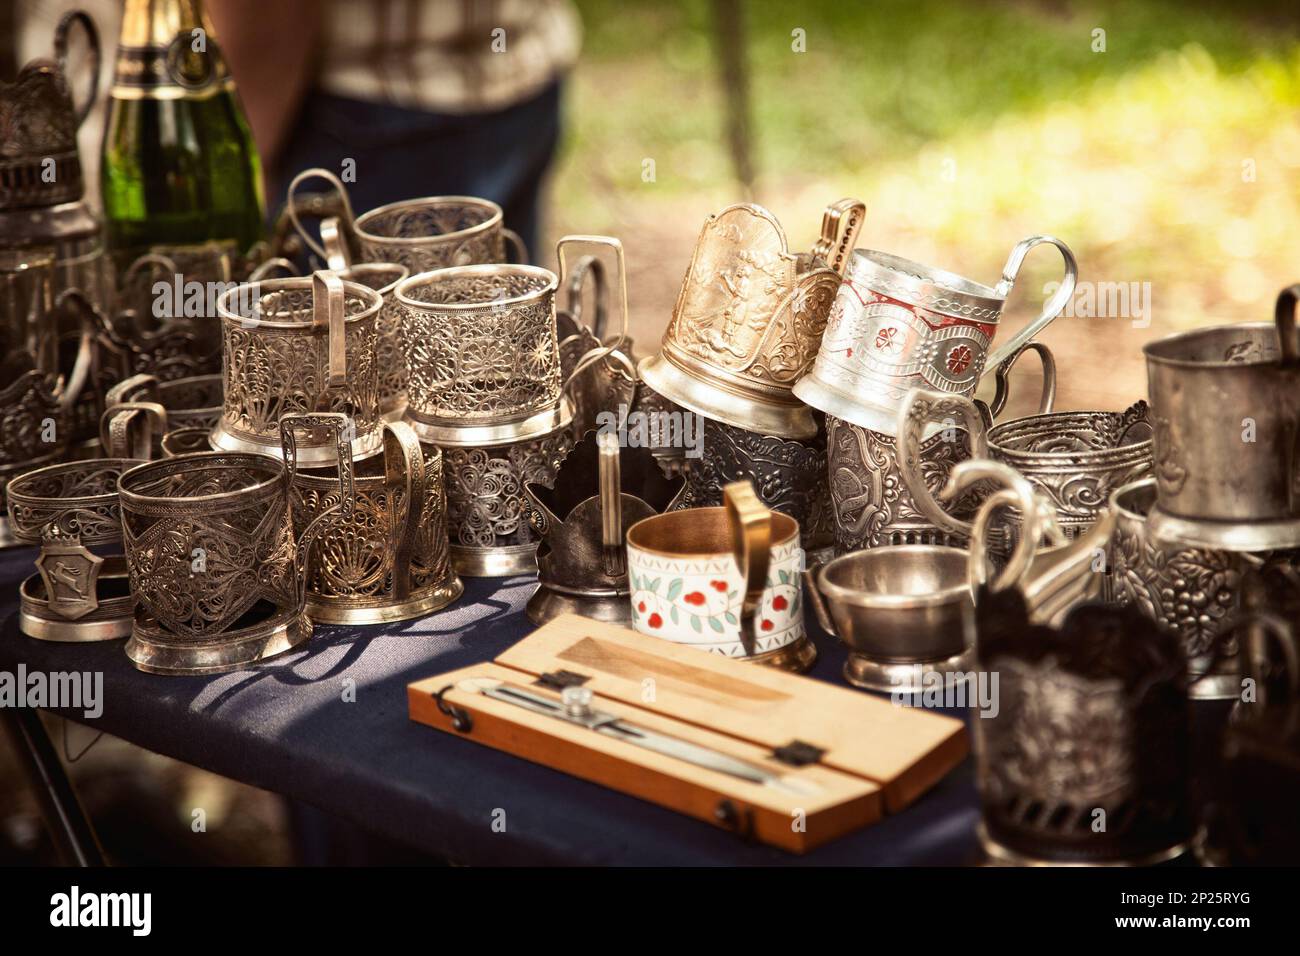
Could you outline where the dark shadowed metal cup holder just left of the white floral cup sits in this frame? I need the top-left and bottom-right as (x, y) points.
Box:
(524, 432), (684, 624)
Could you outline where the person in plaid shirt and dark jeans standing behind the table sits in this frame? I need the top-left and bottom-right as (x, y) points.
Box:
(209, 0), (581, 255)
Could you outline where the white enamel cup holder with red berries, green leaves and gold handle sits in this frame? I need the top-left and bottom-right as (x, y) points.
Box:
(627, 481), (816, 671)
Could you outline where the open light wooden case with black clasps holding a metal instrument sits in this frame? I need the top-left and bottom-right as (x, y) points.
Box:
(407, 615), (967, 853)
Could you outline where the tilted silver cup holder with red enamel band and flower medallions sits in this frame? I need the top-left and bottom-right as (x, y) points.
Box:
(794, 235), (1078, 436)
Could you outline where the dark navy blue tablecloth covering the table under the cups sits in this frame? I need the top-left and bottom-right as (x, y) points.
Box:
(0, 549), (978, 865)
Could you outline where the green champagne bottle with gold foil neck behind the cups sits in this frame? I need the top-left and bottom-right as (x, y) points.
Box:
(100, 0), (264, 268)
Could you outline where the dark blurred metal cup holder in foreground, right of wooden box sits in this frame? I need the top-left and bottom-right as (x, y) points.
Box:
(971, 588), (1193, 866)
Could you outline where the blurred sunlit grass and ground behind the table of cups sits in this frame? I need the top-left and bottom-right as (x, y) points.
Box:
(537, 0), (1300, 410)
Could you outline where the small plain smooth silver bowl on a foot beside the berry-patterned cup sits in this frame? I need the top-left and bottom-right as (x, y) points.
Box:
(805, 545), (975, 693)
